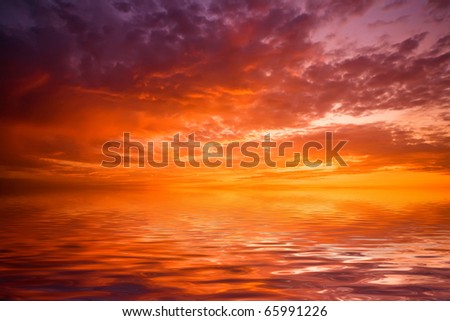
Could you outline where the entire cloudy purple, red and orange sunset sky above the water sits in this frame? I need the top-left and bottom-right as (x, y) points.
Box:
(0, 0), (450, 189)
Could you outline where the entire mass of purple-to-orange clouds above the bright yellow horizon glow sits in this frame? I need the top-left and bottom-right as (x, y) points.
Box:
(0, 0), (450, 178)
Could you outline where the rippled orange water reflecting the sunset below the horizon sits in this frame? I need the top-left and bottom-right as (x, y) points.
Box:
(0, 190), (450, 300)
